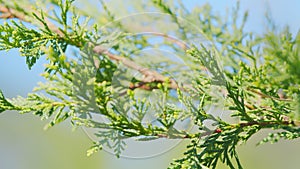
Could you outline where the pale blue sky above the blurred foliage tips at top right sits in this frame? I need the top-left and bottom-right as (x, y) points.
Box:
(185, 0), (300, 34)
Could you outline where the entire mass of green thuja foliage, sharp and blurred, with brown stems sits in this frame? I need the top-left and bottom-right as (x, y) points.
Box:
(0, 0), (300, 169)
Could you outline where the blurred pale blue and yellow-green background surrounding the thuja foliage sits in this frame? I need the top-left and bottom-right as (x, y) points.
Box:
(0, 0), (300, 169)
